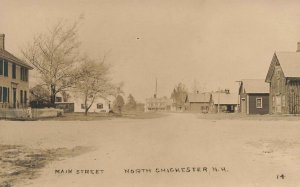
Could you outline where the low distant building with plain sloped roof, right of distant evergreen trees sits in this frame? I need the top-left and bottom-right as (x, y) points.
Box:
(185, 92), (213, 113)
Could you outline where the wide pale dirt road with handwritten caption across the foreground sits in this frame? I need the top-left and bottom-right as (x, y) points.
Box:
(0, 114), (300, 187)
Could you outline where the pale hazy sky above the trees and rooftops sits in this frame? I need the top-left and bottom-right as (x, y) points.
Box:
(0, 0), (300, 102)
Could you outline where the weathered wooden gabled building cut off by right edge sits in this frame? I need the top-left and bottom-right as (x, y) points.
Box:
(265, 42), (300, 114)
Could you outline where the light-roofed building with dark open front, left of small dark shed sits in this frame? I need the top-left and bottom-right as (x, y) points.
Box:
(212, 90), (238, 113)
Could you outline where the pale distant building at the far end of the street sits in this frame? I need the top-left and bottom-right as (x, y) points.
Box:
(145, 95), (173, 112)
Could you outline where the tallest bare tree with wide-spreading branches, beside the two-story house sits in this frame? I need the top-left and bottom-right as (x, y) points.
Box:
(21, 21), (80, 105)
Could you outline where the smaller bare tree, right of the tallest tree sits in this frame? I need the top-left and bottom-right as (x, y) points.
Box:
(74, 57), (118, 115)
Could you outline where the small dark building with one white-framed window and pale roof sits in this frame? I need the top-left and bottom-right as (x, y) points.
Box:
(239, 79), (269, 114)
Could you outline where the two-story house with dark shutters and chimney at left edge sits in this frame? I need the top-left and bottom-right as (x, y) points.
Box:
(0, 34), (33, 108)
